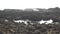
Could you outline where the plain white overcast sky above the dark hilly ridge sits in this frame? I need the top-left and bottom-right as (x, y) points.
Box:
(0, 0), (60, 10)
